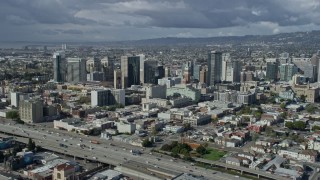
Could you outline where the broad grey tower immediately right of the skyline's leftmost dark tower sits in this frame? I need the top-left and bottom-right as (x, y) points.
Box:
(67, 58), (87, 83)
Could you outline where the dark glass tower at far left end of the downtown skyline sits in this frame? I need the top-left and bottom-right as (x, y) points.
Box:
(53, 51), (67, 83)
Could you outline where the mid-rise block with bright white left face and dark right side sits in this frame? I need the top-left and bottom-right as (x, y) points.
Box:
(91, 89), (110, 107)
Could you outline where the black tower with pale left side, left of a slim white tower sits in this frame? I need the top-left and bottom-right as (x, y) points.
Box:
(121, 56), (144, 88)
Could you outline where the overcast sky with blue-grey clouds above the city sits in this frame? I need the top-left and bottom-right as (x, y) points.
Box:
(0, 0), (320, 42)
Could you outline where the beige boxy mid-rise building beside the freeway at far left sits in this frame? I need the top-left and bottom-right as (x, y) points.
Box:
(19, 100), (43, 123)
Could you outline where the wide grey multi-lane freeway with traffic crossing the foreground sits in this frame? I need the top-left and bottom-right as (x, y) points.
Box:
(0, 123), (244, 180)
